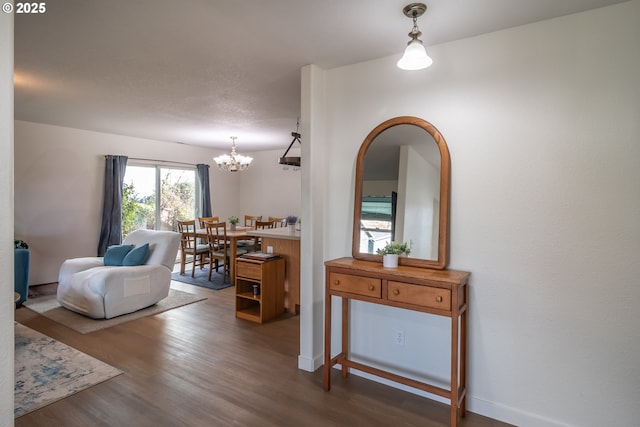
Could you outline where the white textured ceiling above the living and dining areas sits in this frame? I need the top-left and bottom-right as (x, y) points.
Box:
(15, 0), (622, 151)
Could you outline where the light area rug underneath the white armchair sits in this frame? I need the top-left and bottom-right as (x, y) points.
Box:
(24, 289), (207, 334)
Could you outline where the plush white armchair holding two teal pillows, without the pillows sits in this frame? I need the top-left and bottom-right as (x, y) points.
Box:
(57, 230), (180, 319)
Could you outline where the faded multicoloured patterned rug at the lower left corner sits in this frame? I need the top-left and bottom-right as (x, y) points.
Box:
(13, 323), (122, 418)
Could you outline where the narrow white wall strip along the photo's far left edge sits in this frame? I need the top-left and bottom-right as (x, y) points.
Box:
(0, 7), (15, 427)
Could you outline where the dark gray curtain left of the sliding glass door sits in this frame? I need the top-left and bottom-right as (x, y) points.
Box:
(98, 156), (127, 256)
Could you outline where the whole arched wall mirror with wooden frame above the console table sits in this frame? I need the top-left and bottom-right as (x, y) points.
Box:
(352, 116), (451, 269)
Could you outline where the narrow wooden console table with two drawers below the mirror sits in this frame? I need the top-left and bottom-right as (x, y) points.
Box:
(324, 258), (469, 427)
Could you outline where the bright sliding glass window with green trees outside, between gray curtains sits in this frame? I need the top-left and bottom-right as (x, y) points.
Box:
(122, 162), (198, 238)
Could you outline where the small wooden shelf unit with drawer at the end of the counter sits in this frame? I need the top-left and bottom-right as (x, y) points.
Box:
(236, 257), (284, 323)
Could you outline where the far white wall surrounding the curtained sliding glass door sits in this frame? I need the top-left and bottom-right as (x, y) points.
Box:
(15, 121), (300, 285)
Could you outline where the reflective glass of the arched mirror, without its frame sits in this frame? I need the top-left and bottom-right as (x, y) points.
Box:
(360, 124), (440, 260)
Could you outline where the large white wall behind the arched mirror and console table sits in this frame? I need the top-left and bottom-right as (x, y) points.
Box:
(310, 0), (640, 427)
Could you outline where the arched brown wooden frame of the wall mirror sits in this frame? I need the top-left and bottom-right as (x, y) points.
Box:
(351, 116), (451, 270)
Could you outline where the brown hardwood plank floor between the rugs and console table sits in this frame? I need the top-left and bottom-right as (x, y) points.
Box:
(15, 282), (507, 427)
